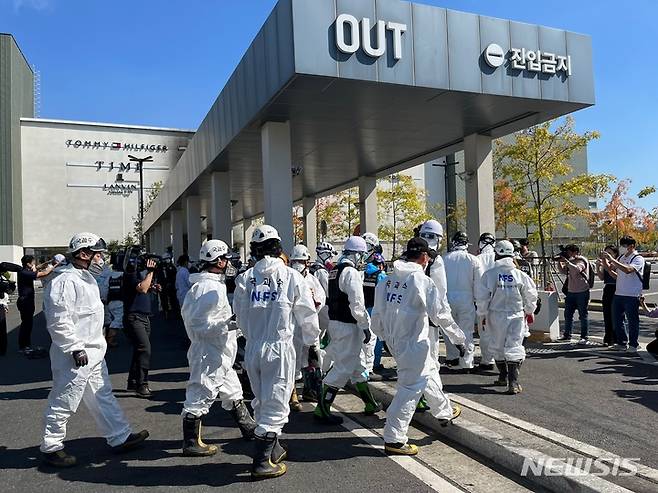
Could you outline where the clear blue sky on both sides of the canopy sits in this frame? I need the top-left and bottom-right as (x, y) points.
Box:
(0, 0), (658, 208)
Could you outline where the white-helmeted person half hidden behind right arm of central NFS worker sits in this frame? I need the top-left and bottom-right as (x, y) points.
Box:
(290, 245), (327, 411)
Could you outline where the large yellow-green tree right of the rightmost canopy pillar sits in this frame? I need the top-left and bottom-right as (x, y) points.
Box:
(494, 117), (614, 283)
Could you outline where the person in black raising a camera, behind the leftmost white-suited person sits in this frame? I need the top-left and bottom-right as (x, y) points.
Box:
(122, 259), (156, 399)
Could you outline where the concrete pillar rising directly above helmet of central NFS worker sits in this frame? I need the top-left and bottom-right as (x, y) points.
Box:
(261, 122), (294, 253)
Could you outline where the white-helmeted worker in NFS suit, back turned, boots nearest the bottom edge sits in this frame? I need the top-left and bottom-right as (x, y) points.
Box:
(233, 225), (320, 479)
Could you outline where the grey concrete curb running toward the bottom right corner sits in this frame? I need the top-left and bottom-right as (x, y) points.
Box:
(370, 382), (631, 493)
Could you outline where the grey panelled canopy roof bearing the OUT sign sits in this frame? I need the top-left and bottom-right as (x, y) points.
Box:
(145, 0), (594, 233)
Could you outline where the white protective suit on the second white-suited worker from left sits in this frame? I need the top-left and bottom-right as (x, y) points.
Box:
(181, 272), (242, 418)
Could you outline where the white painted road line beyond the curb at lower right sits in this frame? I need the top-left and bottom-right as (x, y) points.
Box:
(450, 394), (658, 483)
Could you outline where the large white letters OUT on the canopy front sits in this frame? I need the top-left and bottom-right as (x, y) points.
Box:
(336, 14), (407, 60)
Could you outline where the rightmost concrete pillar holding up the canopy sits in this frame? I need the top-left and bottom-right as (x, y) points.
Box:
(464, 134), (496, 252)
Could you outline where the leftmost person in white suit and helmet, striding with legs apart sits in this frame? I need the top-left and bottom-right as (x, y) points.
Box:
(40, 233), (149, 467)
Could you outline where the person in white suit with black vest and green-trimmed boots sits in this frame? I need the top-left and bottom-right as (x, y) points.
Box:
(314, 236), (382, 424)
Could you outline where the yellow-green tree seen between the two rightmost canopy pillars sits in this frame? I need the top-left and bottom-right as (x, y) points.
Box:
(377, 173), (431, 258)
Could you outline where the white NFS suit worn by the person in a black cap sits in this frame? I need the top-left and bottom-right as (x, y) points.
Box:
(372, 260), (465, 443)
